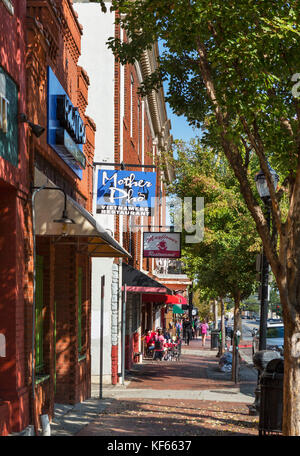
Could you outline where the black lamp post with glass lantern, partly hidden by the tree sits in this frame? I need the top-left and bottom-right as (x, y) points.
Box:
(249, 166), (279, 415)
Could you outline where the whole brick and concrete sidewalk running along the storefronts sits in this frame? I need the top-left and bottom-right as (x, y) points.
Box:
(51, 340), (257, 436)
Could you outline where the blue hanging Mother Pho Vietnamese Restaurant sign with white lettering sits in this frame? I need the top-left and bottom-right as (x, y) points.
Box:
(96, 169), (156, 216)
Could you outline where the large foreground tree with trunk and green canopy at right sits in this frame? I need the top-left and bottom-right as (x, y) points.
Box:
(102, 0), (300, 435)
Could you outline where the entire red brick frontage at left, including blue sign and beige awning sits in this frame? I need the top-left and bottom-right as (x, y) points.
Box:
(0, 0), (126, 435)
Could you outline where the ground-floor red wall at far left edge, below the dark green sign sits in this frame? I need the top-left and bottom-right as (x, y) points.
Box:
(0, 186), (29, 435)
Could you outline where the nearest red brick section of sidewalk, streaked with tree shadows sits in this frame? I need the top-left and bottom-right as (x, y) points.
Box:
(77, 399), (257, 436)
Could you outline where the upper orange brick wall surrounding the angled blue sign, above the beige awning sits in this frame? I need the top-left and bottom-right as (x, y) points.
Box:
(27, 0), (96, 210)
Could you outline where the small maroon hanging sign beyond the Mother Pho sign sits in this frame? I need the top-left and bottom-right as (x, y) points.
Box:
(143, 233), (181, 258)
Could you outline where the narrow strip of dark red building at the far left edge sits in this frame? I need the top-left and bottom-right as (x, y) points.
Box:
(0, 0), (29, 435)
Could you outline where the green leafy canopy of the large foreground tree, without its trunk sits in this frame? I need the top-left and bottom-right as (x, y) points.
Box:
(105, 0), (300, 182)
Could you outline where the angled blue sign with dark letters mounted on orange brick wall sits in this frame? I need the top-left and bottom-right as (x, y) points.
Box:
(47, 67), (86, 179)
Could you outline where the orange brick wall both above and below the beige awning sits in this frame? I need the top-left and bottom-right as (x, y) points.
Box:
(26, 0), (96, 424)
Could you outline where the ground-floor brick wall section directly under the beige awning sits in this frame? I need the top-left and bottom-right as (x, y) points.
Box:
(55, 246), (91, 404)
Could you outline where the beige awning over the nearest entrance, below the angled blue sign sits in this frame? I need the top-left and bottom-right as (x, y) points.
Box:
(34, 178), (130, 258)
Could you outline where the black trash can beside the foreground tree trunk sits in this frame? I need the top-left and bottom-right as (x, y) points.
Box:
(259, 358), (283, 435)
